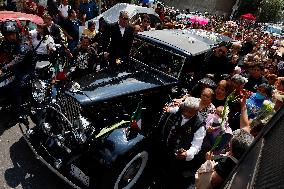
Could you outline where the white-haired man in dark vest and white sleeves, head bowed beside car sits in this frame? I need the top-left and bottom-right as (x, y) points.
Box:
(161, 97), (206, 188)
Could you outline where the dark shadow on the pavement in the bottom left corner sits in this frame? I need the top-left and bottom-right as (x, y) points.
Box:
(5, 137), (70, 189)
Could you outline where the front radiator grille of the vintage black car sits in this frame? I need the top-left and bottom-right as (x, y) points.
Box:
(58, 93), (81, 125)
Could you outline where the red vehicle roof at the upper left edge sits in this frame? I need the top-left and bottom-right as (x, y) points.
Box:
(0, 11), (43, 24)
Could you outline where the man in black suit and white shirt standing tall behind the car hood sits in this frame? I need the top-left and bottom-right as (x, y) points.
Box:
(108, 11), (134, 67)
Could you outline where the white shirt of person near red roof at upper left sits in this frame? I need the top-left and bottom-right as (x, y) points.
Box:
(30, 30), (55, 55)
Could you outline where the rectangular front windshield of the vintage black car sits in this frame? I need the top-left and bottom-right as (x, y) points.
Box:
(131, 39), (185, 78)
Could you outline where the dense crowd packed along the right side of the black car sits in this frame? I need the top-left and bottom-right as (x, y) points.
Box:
(152, 2), (284, 188)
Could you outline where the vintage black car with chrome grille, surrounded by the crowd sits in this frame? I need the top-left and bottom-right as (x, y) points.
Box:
(21, 30), (230, 189)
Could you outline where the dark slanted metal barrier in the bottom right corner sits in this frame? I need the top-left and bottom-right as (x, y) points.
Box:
(224, 107), (284, 189)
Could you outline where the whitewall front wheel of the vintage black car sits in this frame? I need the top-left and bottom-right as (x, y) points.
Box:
(113, 151), (149, 189)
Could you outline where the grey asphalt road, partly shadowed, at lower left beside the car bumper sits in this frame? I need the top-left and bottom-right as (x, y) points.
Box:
(0, 111), (70, 189)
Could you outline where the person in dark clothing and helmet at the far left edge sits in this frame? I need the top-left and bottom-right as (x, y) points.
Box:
(0, 21), (33, 124)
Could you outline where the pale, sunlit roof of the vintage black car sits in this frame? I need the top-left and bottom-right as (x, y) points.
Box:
(138, 29), (232, 55)
